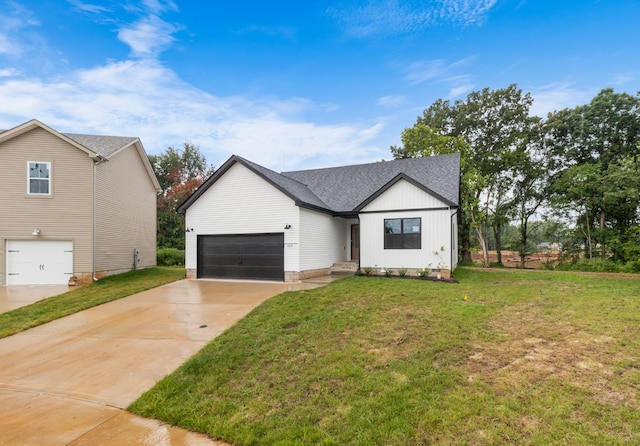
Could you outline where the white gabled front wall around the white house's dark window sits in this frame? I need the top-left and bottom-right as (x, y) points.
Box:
(360, 180), (454, 269)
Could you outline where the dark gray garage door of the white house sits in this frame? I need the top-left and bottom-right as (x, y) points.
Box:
(198, 233), (284, 281)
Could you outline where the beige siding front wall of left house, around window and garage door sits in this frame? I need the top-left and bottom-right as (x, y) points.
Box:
(0, 128), (93, 285)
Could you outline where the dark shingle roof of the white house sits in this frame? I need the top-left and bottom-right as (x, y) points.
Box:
(177, 153), (460, 214)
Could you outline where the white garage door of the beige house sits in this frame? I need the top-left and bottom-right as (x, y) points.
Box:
(6, 240), (73, 285)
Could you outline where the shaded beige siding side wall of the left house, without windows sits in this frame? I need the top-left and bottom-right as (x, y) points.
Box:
(96, 145), (157, 274)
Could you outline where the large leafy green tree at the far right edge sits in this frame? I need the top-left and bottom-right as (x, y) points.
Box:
(546, 88), (640, 260)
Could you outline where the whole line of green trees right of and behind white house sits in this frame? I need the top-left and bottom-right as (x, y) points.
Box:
(391, 84), (640, 268)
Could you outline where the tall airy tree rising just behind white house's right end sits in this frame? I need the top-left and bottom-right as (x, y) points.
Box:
(403, 84), (536, 266)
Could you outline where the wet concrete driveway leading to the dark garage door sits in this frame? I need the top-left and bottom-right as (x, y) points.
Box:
(0, 280), (296, 446)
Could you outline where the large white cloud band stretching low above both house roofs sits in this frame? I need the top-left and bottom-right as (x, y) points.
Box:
(0, 60), (387, 170)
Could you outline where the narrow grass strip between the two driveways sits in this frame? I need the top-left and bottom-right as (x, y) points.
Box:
(0, 267), (184, 338)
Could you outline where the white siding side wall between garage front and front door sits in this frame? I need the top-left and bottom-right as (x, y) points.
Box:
(300, 209), (347, 271)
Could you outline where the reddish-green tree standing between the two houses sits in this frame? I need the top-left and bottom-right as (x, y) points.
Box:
(149, 143), (214, 249)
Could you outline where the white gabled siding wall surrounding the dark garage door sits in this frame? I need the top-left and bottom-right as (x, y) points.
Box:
(185, 163), (300, 271)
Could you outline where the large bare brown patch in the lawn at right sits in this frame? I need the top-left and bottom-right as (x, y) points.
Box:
(463, 303), (640, 409)
